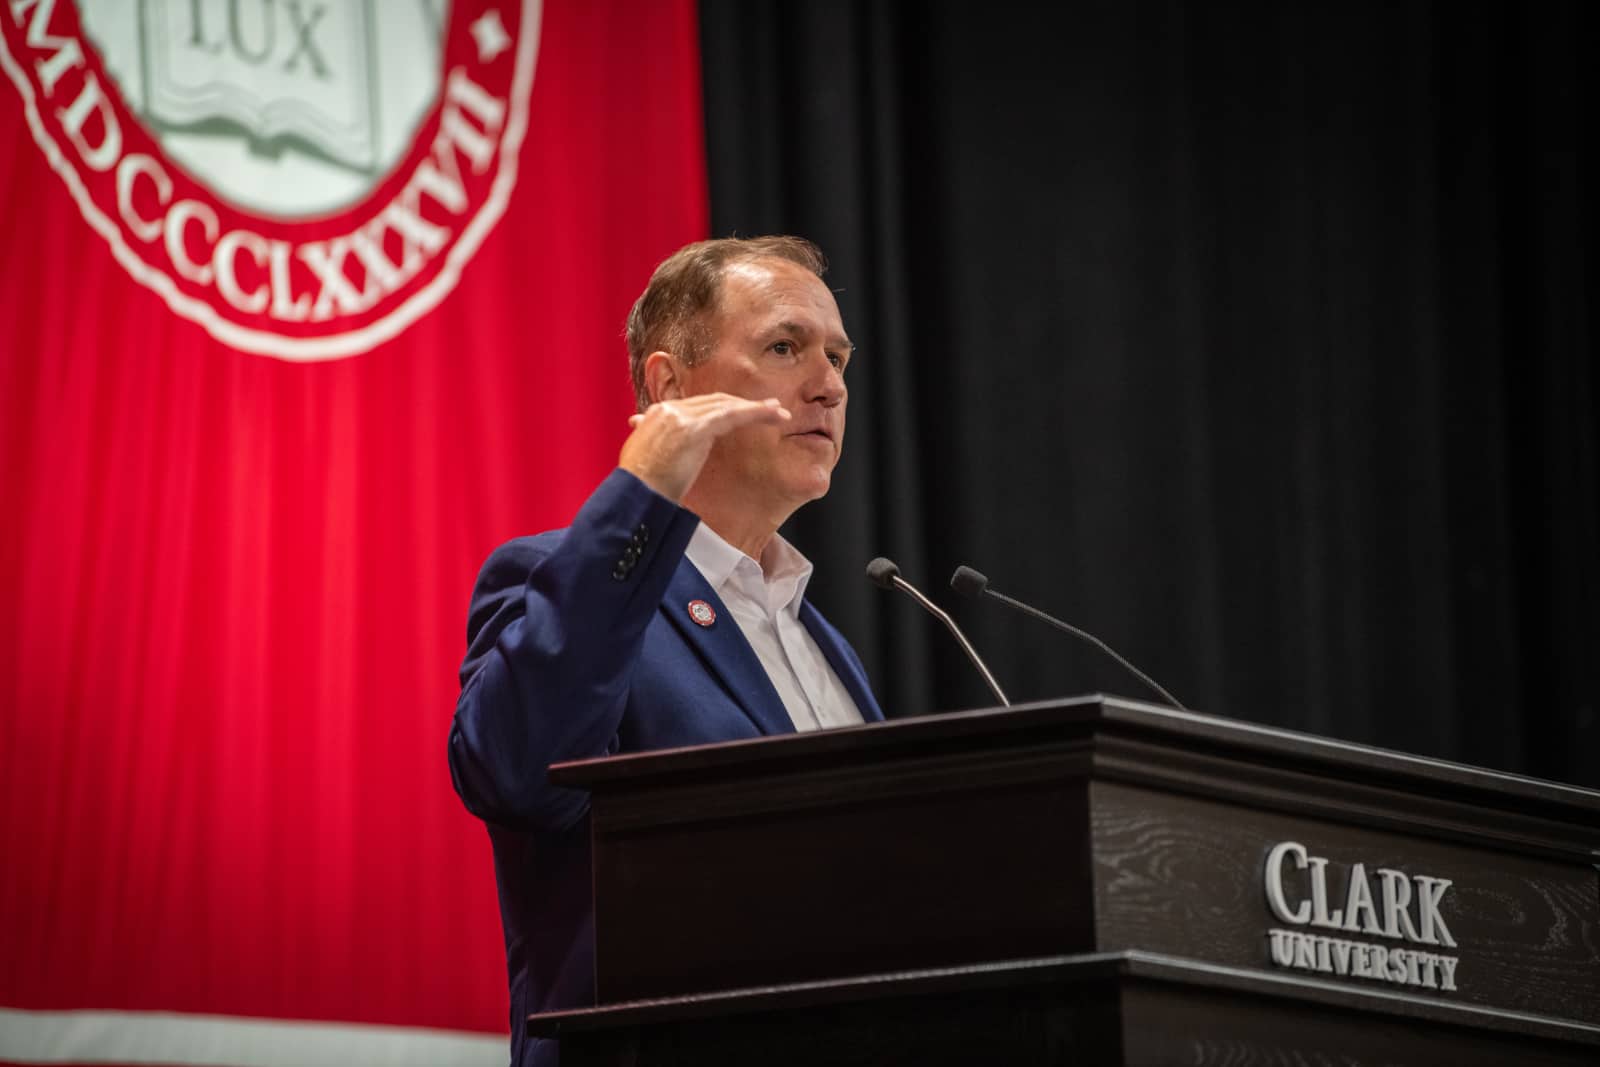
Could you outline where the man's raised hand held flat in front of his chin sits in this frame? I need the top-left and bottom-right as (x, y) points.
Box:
(618, 394), (790, 502)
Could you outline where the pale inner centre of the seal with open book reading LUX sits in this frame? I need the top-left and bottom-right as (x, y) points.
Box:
(80, 0), (448, 218)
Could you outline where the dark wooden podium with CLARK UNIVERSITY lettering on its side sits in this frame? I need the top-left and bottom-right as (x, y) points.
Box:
(528, 696), (1600, 1067)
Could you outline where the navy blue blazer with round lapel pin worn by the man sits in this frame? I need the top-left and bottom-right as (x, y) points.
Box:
(450, 470), (883, 1067)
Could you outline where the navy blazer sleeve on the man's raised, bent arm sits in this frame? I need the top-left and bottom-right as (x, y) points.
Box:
(450, 469), (699, 829)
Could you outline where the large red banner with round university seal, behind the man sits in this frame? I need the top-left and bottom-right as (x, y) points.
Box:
(0, 0), (706, 1062)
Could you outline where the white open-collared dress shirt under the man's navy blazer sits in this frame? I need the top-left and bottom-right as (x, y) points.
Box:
(686, 523), (862, 731)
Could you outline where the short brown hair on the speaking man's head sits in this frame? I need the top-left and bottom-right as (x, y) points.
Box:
(627, 237), (827, 411)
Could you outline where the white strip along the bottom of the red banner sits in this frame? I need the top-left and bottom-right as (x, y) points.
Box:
(0, 1008), (507, 1067)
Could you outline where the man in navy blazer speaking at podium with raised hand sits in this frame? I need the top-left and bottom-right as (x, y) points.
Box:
(450, 237), (883, 1067)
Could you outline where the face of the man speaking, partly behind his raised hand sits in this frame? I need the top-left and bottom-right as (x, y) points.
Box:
(683, 259), (851, 522)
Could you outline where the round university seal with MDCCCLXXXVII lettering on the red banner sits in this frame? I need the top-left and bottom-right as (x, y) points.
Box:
(0, 0), (539, 360)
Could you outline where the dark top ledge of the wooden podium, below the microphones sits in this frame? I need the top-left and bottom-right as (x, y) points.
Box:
(550, 693), (1600, 831)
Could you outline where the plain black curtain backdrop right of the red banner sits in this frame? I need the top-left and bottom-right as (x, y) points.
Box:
(702, 0), (1600, 785)
